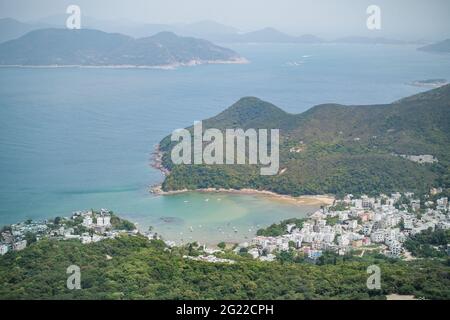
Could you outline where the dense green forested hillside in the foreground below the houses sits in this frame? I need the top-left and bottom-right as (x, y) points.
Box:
(0, 236), (450, 299)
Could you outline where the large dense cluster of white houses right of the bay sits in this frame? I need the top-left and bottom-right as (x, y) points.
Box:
(235, 191), (450, 261)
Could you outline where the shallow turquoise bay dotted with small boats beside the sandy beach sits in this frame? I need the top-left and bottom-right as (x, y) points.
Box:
(121, 192), (318, 244)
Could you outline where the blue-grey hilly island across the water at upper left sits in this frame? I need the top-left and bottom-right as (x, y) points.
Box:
(0, 29), (243, 66)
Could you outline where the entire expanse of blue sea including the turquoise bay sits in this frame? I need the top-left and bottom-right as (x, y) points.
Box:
(0, 45), (450, 244)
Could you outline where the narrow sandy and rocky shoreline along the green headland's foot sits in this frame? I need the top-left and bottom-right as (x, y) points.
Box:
(150, 186), (335, 205)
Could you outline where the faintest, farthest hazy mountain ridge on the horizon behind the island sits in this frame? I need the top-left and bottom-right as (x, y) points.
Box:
(0, 15), (425, 45)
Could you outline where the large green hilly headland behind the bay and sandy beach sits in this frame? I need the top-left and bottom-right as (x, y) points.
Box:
(160, 85), (450, 196)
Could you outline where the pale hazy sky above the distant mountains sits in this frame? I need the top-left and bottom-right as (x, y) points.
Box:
(0, 0), (450, 39)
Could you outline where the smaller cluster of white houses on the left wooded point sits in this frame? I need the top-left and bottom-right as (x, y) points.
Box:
(0, 209), (138, 255)
